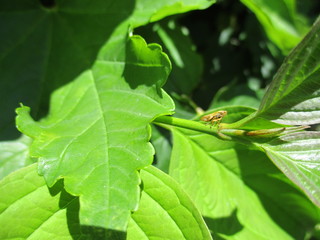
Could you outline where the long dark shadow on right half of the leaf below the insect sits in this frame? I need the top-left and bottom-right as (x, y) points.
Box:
(237, 149), (318, 239)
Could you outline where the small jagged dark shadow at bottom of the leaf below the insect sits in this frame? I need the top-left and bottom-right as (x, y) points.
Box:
(204, 209), (243, 240)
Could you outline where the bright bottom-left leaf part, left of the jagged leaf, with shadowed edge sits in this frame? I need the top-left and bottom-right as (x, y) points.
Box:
(0, 164), (85, 239)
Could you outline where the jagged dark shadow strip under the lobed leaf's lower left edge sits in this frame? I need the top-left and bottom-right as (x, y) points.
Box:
(49, 180), (126, 240)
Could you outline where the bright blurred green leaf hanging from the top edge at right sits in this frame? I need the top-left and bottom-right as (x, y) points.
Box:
(241, 0), (308, 54)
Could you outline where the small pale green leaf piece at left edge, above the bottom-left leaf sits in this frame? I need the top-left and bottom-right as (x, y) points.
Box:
(0, 136), (34, 179)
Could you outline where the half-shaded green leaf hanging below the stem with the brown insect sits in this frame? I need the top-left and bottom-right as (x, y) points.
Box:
(169, 108), (320, 239)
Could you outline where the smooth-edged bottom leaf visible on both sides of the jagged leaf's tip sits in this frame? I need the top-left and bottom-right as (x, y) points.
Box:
(0, 164), (211, 240)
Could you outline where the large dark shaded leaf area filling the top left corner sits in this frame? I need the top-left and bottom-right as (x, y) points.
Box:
(0, 0), (135, 140)
